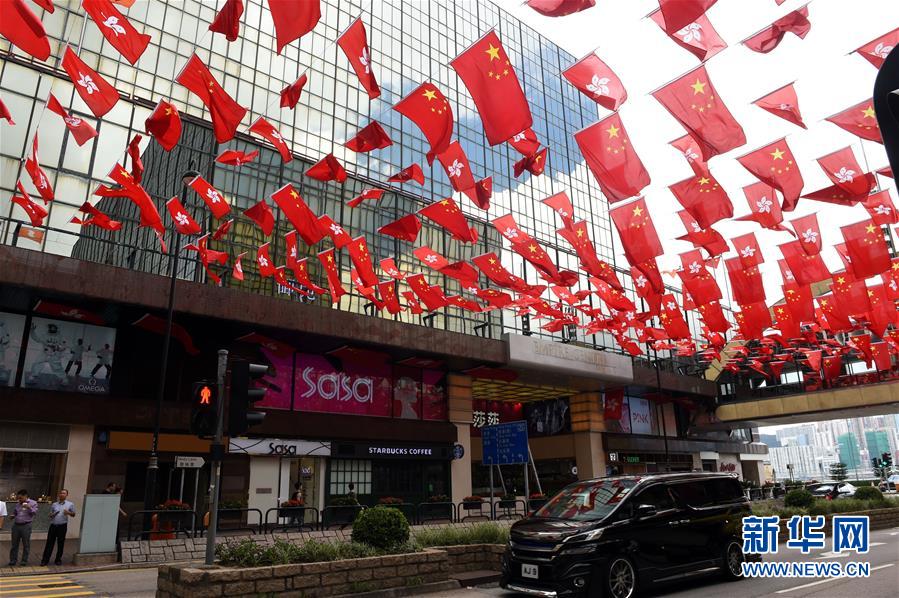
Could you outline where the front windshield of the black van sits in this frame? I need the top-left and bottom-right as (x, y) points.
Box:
(533, 479), (639, 521)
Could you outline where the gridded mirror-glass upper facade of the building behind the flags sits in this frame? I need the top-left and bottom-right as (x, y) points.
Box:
(0, 0), (712, 350)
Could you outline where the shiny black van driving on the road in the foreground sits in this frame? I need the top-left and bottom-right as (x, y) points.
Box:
(500, 473), (750, 598)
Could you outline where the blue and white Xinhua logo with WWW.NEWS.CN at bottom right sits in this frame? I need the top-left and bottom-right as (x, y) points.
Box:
(742, 515), (871, 578)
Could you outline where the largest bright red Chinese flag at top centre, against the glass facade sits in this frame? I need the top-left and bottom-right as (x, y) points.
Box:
(450, 30), (533, 145)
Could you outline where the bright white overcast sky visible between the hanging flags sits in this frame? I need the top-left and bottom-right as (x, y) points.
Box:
(495, 0), (899, 304)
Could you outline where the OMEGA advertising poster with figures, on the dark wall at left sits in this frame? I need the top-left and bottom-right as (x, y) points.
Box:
(22, 318), (116, 394)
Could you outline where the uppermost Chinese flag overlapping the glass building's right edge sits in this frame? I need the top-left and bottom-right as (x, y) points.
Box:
(574, 113), (650, 203)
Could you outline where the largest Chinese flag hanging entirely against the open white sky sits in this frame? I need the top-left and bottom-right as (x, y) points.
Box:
(652, 66), (746, 162)
